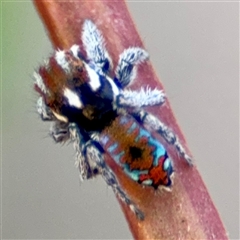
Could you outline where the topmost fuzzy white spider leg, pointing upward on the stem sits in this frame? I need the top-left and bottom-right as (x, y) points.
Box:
(82, 20), (112, 73)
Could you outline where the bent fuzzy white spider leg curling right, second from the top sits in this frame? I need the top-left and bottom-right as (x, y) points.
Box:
(115, 47), (148, 88)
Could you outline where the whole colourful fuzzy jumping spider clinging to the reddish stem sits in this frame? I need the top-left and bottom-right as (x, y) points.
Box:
(34, 20), (191, 220)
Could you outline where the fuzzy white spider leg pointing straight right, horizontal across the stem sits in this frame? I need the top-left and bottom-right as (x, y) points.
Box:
(117, 88), (166, 108)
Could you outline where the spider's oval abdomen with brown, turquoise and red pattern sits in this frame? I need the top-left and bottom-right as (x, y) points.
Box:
(100, 115), (173, 189)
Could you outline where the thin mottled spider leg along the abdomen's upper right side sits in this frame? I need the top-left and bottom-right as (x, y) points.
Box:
(133, 109), (193, 165)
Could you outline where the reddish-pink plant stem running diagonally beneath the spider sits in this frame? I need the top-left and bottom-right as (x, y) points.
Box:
(34, 0), (228, 240)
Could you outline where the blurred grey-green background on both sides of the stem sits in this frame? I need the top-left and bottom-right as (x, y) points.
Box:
(1, 1), (239, 239)
